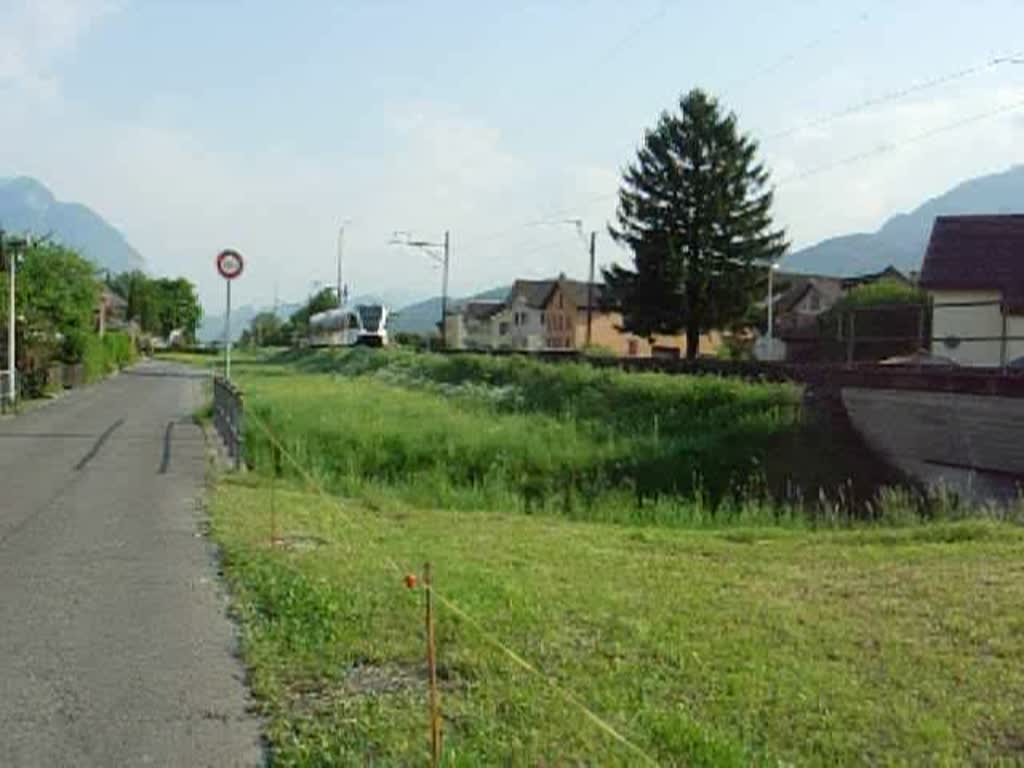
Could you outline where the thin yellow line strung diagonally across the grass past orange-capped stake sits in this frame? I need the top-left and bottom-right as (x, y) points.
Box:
(238, 413), (659, 766)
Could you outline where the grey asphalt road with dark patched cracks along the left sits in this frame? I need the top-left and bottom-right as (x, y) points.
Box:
(0, 362), (262, 768)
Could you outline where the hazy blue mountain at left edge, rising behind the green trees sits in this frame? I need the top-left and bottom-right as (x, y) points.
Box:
(0, 176), (145, 272)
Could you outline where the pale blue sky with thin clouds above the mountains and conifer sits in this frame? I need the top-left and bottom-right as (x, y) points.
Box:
(0, 0), (1024, 309)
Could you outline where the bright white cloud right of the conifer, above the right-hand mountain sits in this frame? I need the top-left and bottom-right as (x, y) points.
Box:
(764, 87), (1024, 246)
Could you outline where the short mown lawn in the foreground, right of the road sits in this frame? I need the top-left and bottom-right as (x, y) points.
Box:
(210, 474), (1024, 766)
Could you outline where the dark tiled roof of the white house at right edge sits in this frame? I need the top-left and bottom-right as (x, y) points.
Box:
(921, 214), (1024, 308)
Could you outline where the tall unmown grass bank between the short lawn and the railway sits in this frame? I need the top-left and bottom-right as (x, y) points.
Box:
(234, 350), (1024, 527)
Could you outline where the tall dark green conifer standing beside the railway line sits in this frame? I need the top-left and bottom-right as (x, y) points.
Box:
(603, 89), (787, 358)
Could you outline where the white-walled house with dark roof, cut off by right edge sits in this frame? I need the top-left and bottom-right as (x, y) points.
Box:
(921, 214), (1024, 367)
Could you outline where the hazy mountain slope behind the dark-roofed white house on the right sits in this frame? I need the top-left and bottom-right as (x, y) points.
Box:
(783, 166), (1024, 276)
